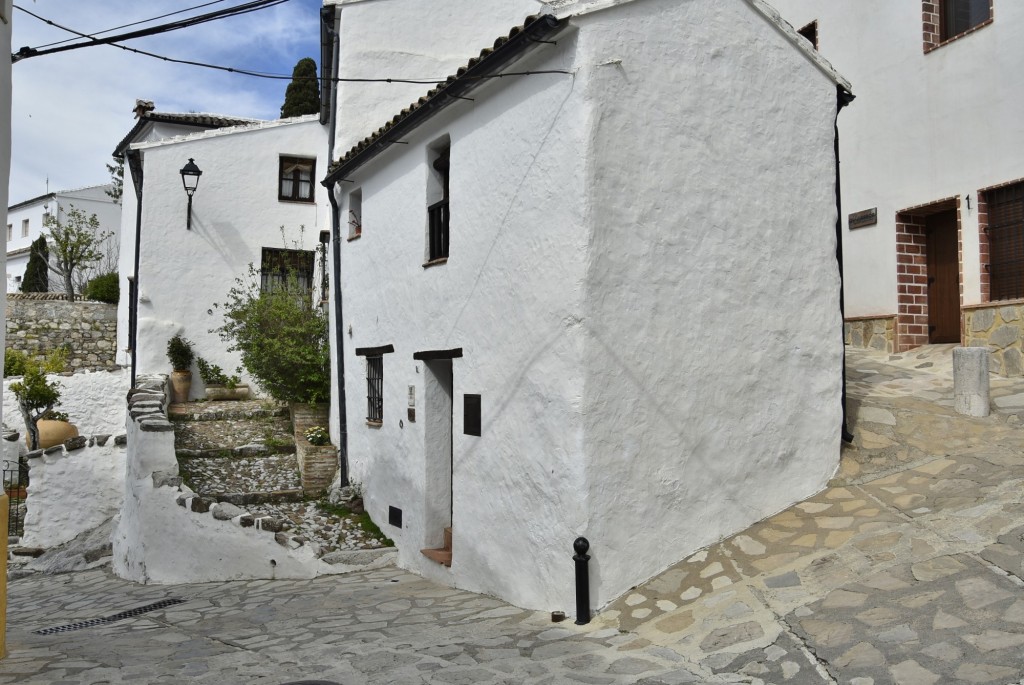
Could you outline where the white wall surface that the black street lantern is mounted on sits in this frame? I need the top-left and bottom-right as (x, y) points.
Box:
(118, 117), (330, 397)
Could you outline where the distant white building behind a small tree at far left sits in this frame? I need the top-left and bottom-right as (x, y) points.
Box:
(7, 183), (121, 293)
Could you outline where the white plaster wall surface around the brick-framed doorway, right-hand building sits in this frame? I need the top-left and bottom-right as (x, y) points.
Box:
(771, 0), (1024, 316)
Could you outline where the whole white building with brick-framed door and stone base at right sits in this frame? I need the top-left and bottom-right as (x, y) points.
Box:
(772, 0), (1024, 368)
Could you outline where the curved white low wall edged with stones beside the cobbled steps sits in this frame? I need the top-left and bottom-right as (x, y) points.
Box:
(113, 376), (335, 584)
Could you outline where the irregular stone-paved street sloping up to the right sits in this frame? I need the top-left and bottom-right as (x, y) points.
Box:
(6, 348), (1024, 685)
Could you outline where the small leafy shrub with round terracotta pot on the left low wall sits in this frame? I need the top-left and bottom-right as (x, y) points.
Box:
(10, 350), (78, 449)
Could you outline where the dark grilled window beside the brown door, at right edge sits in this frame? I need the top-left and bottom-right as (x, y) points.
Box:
(985, 183), (1024, 301)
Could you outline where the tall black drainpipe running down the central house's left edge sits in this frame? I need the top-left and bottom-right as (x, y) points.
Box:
(321, 7), (348, 486)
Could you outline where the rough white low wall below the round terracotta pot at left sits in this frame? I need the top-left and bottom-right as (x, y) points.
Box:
(22, 437), (126, 548)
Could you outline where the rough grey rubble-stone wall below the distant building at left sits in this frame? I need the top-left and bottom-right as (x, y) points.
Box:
(6, 293), (118, 371)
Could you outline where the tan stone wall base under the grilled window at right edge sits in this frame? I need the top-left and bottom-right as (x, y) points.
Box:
(964, 300), (1024, 377)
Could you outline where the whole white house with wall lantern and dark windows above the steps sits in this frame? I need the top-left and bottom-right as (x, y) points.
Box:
(116, 109), (328, 397)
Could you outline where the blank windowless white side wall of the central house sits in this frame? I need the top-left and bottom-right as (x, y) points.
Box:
(579, 0), (842, 606)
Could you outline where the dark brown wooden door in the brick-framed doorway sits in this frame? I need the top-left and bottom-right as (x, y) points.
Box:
(927, 210), (961, 343)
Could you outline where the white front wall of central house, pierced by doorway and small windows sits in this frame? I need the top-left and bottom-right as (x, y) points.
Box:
(341, 35), (587, 608)
